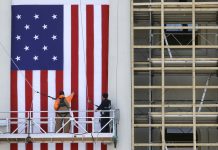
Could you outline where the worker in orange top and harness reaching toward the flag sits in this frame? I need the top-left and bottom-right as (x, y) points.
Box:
(54, 91), (74, 133)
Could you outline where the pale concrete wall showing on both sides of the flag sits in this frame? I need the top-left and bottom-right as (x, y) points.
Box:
(0, 0), (131, 150)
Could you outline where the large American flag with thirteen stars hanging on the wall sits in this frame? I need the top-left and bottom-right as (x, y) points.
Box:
(11, 0), (109, 150)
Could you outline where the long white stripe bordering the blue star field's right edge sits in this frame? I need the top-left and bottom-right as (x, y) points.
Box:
(63, 5), (71, 150)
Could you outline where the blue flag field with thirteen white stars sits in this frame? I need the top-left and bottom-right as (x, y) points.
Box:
(12, 5), (64, 70)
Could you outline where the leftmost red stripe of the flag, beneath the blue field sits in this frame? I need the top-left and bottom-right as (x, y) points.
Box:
(10, 70), (18, 150)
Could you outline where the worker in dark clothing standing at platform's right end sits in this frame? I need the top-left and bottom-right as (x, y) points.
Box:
(96, 93), (111, 133)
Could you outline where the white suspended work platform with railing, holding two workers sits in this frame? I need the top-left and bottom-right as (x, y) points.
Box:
(0, 109), (119, 146)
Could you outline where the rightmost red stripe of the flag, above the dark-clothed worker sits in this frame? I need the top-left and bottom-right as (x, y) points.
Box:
(101, 5), (109, 150)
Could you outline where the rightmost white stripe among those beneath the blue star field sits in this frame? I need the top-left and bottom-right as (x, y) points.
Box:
(48, 71), (56, 150)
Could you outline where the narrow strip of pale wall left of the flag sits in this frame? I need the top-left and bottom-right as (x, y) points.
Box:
(0, 0), (11, 150)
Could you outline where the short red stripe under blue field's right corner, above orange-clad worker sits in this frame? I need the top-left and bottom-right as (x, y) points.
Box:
(56, 70), (63, 150)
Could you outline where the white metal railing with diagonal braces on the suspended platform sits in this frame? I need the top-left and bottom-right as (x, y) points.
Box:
(0, 109), (119, 137)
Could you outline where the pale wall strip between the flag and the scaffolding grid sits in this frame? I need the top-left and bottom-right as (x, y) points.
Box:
(109, 0), (131, 150)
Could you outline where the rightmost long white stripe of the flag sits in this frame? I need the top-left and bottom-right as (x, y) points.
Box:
(93, 5), (102, 150)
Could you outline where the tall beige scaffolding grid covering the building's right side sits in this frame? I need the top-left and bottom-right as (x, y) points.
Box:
(131, 0), (218, 150)
